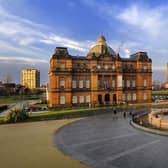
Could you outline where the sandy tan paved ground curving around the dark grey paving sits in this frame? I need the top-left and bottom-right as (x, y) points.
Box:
(0, 119), (88, 168)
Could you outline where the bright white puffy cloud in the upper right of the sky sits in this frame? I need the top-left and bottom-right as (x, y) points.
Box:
(117, 5), (168, 38)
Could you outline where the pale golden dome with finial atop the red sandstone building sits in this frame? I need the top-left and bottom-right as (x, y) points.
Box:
(88, 35), (116, 57)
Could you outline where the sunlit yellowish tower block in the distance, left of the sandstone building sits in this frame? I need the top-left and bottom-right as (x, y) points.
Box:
(22, 69), (40, 89)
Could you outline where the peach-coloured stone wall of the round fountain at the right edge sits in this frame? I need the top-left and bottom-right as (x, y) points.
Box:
(148, 109), (168, 129)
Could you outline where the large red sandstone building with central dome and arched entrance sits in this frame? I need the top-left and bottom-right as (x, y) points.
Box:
(49, 35), (152, 107)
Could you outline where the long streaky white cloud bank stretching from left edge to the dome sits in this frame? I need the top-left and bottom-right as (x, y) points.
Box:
(0, 3), (93, 62)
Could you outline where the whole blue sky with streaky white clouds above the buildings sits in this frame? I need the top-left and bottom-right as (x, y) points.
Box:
(0, 0), (168, 83)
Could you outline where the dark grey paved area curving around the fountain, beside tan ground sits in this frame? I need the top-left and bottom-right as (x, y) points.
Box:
(54, 113), (168, 168)
